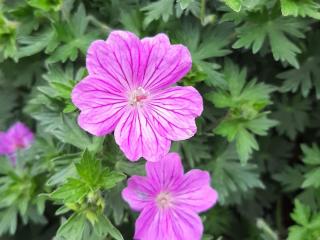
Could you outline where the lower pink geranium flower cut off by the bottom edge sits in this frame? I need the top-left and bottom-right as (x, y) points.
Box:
(122, 153), (218, 240)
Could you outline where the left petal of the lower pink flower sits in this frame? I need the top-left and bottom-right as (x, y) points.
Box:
(122, 176), (156, 211)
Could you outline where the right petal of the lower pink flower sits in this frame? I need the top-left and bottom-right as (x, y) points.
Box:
(174, 169), (218, 212)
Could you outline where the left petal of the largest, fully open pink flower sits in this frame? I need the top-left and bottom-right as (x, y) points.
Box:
(72, 76), (128, 136)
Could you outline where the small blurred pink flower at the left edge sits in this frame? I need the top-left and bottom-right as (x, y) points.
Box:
(0, 122), (34, 163)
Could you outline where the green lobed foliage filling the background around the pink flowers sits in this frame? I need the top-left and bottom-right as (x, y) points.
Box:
(0, 0), (320, 240)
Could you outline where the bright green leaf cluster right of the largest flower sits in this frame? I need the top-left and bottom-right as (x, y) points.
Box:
(205, 61), (278, 164)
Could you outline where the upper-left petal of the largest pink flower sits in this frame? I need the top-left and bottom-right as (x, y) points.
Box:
(87, 31), (146, 89)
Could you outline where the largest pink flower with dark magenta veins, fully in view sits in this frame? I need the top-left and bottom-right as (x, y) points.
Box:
(72, 31), (203, 161)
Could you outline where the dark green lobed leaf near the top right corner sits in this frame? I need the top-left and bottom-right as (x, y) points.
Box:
(233, 11), (306, 68)
